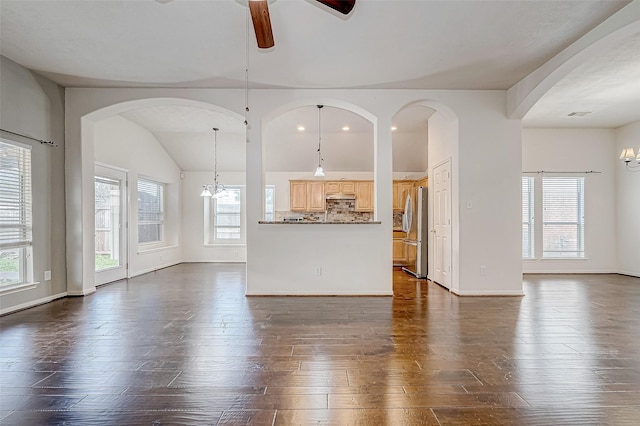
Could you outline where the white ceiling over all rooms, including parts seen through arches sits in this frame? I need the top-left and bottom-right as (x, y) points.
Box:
(0, 0), (640, 170)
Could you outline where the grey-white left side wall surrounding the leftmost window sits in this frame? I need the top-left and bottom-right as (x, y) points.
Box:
(0, 56), (67, 314)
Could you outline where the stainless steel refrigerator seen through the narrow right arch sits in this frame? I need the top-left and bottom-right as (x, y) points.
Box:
(402, 186), (429, 278)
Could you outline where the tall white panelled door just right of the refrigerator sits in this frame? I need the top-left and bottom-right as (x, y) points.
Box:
(429, 160), (451, 288)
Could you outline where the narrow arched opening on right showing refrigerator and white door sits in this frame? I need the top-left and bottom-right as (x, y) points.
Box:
(392, 100), (459, 289)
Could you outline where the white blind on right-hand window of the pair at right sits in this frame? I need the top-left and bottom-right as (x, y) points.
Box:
(542, 177), (584, 258)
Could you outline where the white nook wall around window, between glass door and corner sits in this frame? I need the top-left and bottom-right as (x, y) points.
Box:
(94, 116), (182, 277)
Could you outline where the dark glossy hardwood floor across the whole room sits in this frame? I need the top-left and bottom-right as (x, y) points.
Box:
(0, 264), (640, 426)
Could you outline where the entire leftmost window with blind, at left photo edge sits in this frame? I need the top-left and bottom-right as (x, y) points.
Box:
(0, 140), (32, 286)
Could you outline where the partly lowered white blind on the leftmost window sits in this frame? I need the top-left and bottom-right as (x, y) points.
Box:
(0, 141), (32, 249)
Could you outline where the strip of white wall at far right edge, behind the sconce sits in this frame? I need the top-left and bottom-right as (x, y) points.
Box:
(610, 121), (640, 277)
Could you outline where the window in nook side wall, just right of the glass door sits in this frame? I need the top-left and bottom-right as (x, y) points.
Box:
(138, 179), (164, 244)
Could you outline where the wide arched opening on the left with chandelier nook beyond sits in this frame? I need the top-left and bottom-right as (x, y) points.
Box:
(69, 98), (246, 287)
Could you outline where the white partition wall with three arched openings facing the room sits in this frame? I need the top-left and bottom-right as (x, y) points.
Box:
(66, 88), (522, 294)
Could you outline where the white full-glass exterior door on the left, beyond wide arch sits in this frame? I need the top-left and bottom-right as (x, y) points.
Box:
(94, 165), (128, 285)
